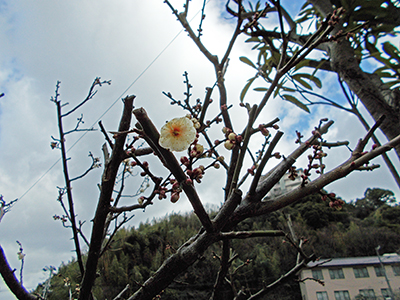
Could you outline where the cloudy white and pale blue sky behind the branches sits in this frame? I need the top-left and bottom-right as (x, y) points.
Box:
(0, 0), (399, 300)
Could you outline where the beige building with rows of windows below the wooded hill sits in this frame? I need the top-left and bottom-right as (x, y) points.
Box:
(299, 254), (400, 300)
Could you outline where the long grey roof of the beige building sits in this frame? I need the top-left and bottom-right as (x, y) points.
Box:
(307, 253), (400, 268)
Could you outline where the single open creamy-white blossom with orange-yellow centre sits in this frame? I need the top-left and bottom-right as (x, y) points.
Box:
(158, 117), (196, 151)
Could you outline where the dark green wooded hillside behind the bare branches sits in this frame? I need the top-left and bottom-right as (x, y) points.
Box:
(35, 188), (400, 300)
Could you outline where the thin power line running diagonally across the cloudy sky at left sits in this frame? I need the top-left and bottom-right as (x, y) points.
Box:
(17, 0), (211, 200)
